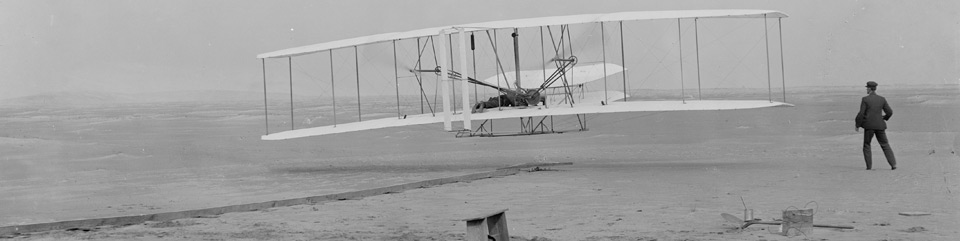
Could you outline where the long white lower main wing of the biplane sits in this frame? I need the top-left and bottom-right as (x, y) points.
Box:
(261, 100), (793, 140)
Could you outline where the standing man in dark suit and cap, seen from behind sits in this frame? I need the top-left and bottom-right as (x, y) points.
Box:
(854, 81), (897, 170)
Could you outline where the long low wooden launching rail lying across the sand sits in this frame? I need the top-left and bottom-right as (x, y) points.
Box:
(0, 169), (518, 236)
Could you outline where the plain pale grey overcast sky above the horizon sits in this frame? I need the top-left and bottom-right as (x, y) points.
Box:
(0, 0), (960, 99)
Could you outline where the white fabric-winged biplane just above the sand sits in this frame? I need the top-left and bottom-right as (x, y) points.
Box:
(257, 10), (792, 140)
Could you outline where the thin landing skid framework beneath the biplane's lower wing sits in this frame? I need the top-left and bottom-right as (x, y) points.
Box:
(456, 114), (589, 138)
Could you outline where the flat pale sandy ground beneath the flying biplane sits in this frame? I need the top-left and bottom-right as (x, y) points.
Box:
(0, 86), (960, 240)
